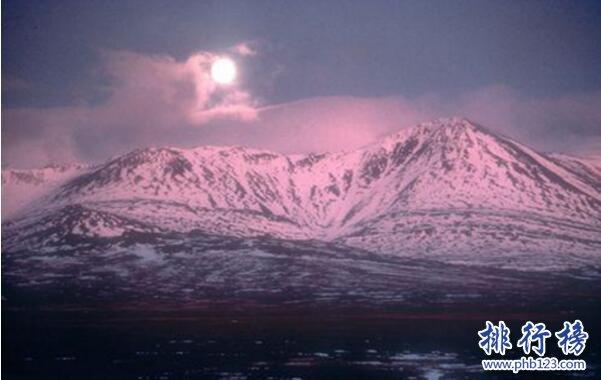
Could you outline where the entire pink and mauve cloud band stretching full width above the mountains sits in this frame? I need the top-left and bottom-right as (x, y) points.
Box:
(2, 60), (601, 166)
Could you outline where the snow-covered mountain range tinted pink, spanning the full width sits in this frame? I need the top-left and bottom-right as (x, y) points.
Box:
(2, 118), (601, 304)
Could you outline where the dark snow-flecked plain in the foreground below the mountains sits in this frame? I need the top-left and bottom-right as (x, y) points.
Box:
(2, 269), (601, 379)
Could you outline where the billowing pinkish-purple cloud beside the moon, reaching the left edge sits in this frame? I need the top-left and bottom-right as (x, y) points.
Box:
(2, 51), (257, 166)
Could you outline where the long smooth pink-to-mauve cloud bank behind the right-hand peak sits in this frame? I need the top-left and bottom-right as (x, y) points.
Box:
(223, 85), (601, 154)
